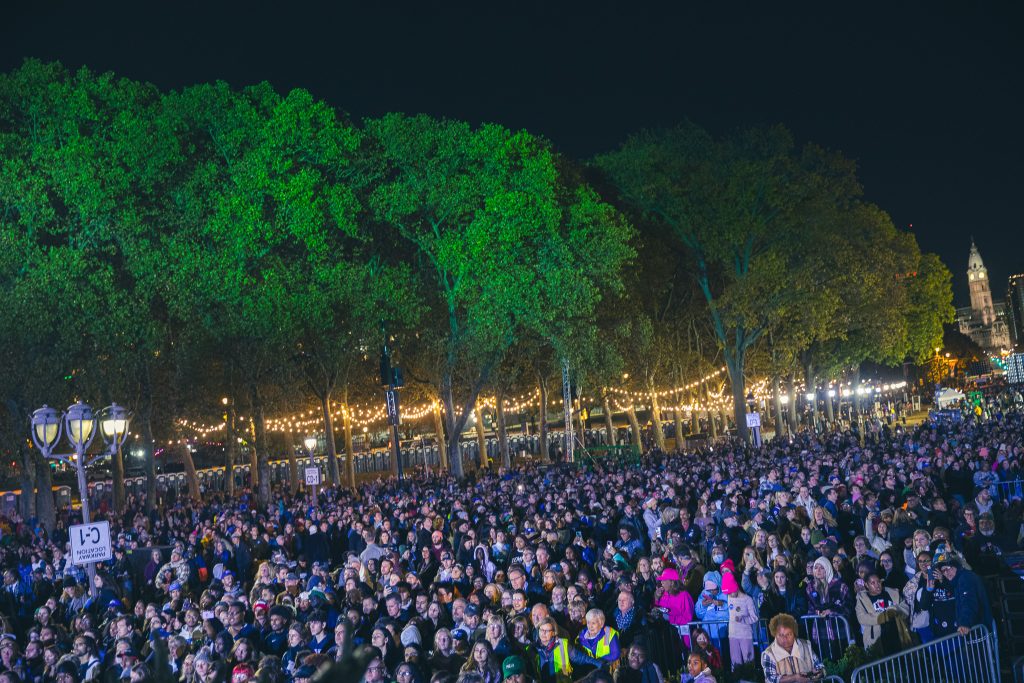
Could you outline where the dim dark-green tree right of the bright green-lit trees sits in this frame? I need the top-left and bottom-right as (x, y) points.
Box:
(595, 123), (876, 437)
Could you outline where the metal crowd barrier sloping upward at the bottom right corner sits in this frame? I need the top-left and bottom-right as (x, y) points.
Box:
(851, 626), (999, 683)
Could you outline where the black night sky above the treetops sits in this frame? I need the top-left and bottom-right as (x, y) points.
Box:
(0, 0), (1024, 302)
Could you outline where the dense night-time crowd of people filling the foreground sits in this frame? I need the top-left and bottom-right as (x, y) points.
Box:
(0, 405), (1011, 683)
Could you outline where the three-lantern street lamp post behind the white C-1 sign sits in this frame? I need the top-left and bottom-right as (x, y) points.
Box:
(32, 401), (131, 596)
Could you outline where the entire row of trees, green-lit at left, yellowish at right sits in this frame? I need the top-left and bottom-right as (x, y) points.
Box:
(0, 60), (951, 514)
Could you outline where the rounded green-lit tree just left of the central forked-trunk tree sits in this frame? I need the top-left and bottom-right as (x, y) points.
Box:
(168, 83), (358, 504)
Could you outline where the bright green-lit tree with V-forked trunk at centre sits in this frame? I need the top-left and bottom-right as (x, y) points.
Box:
(367, 115), (632, 476)
